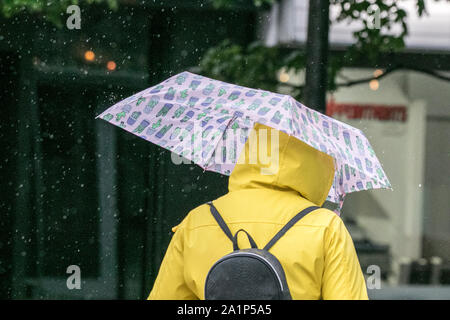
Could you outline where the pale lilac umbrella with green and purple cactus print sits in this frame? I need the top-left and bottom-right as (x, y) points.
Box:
(97, 72), (391, 207)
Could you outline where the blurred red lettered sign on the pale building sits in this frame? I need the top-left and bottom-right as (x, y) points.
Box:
(326, 101), (407, 122)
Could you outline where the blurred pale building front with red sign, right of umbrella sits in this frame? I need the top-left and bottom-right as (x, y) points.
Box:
(260, 0), (450, 298)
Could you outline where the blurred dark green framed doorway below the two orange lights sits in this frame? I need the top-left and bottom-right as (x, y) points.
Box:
(13, 66), (145, 299)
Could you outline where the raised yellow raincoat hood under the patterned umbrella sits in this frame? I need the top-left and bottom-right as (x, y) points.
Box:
(228, 123), (334, 206)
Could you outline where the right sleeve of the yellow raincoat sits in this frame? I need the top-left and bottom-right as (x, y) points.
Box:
(322, 216), (368, 300)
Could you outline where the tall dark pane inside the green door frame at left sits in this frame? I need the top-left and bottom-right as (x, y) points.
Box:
(35, 86), (99, 277)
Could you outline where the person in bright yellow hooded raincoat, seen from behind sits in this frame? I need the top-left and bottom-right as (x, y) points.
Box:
(148, 124), (368, 300)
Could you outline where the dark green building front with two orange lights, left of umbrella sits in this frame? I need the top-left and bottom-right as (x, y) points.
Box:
(0, 1), (255, 299)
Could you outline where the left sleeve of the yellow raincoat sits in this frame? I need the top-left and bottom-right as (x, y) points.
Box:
(148, 225), (197, 300)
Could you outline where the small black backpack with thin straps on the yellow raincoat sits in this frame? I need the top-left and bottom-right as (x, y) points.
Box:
(205, 202), (319, 300)
